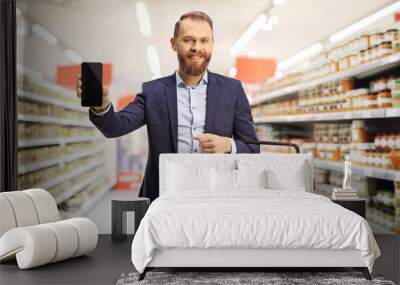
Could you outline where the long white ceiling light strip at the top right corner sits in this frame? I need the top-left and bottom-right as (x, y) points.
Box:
(329, 1), (400, 43)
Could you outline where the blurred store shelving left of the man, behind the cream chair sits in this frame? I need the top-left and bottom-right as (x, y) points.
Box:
(17, 68), (117, 218)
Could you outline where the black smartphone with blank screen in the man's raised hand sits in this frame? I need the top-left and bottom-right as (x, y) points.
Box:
(81, 62), (103, 107)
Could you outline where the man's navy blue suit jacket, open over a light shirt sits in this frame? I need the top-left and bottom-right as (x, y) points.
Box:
(89, 72), (260, 201)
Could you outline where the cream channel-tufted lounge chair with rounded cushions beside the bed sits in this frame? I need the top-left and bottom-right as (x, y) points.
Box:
(0, 189), (98, 269)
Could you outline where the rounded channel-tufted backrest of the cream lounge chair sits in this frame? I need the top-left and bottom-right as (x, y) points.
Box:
(0, 189), (60, 237)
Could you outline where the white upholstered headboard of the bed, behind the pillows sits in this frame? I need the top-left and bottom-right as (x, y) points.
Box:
(159, 154), (313, 196)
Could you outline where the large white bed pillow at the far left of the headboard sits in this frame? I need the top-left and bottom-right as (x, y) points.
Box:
(167, 163), (211, 191)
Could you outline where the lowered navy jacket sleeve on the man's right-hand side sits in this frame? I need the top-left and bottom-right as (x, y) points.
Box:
(233, 81), (260, 153)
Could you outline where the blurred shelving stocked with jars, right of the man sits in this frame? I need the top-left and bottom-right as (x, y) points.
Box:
(250, 33), (400, 234)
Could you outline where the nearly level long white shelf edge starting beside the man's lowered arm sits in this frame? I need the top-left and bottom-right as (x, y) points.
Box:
(254, 108), (400, 124)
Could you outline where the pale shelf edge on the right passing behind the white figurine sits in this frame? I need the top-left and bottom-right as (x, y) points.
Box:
(314, 159), (400, 181)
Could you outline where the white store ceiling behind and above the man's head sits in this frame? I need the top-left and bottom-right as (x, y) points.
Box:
(17, 0), (396, 96)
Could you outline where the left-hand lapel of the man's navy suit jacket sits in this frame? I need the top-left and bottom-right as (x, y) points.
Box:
(164, 73), (178, 153)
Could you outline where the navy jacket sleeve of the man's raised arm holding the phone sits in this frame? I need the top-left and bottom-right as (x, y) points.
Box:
(89, 93), (146, 138)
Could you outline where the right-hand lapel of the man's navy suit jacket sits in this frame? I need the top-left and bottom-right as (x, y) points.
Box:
(204, 72), (219, 133)
